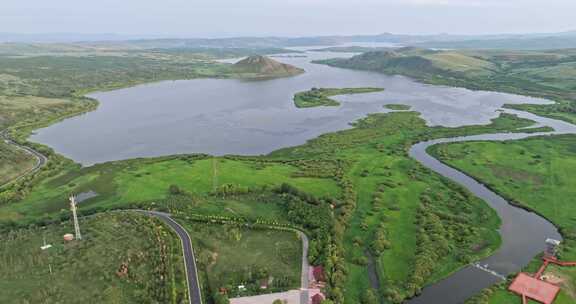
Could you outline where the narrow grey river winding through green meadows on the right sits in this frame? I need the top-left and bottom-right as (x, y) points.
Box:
(409, 110), (576, 304)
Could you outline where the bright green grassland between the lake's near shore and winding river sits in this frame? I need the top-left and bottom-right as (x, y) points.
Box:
(0, 111), (533, 302)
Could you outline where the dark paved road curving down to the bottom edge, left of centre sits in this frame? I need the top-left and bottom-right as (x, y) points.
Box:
(141, 211), (202, 304)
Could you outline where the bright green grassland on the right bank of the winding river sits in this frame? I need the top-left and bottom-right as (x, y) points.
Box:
(432, 135), (576, 303)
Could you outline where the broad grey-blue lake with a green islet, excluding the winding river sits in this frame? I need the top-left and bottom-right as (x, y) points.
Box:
(31, 52), (545, 165)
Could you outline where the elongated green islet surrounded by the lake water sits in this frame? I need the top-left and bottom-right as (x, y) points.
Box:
(294, 88), (384, 108)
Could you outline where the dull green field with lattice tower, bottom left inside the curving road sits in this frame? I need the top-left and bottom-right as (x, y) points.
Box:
(0, 213), (188, 303)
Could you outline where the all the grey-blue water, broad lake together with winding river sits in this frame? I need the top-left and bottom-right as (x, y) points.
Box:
(31, 47), (576, 304)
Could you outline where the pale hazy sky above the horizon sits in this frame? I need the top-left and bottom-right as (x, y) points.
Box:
(0, 0), (576, 37)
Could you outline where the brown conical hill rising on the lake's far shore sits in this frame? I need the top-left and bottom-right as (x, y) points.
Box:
(233, 55), (304, 78)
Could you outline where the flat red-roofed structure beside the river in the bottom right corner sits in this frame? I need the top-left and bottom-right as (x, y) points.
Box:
(508, 273), (560, 304)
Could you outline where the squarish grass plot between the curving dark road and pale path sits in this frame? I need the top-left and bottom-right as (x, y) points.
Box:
(184, 222), (302, 297)
